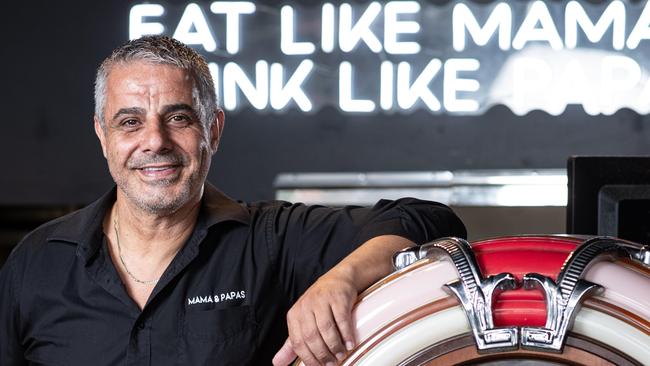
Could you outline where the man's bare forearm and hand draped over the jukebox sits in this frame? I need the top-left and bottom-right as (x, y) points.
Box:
(273, 235), (413, 366)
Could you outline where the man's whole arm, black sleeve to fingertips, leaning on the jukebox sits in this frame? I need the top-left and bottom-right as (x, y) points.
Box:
(270, 198), (467, 366)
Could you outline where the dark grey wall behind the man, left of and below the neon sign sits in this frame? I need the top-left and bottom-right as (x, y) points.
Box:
(0, 1), (650, 205)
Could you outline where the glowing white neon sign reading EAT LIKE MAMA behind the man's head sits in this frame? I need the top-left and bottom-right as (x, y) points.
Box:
(129, 0), (650, 115)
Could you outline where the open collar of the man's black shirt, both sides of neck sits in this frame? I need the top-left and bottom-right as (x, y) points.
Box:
(47, 182), (250, 261)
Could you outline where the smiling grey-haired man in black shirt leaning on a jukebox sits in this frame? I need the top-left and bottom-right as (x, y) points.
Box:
(0, 36), (465, 365)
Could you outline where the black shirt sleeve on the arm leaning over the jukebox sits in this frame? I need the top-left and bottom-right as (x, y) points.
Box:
(267, 198), (467, 303)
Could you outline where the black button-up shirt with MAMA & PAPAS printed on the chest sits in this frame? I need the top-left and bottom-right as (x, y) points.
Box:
(0, 184), (465, 366)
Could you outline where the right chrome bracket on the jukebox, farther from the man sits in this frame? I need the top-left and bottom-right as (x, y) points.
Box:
(521, 237), (650, 352)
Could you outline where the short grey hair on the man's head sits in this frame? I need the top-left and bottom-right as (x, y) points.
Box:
(95, 36), (218, 129)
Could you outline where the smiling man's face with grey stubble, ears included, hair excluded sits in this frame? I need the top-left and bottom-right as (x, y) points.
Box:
(95, 62), (223, 215)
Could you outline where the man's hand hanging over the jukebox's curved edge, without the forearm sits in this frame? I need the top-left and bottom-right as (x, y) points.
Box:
(273, 267), (358, 366)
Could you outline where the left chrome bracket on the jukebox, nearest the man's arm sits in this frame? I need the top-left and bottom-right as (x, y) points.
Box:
(393, 238), (519, 352)
